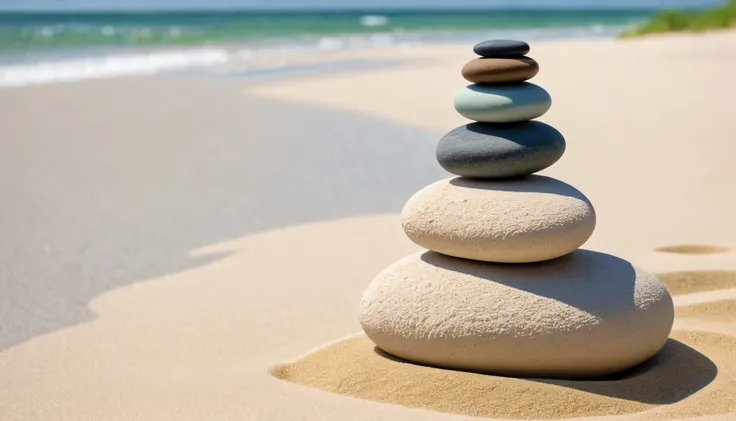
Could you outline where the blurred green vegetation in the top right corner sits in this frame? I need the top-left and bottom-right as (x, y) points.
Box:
(621, 0), (736, 38)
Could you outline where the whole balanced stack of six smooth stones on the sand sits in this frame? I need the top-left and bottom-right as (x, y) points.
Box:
(360, 40), (674, 379)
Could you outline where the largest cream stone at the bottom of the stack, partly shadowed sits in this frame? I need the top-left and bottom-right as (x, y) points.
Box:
(360, 250), (674, 378)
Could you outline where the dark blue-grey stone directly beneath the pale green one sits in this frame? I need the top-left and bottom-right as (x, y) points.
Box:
(437, 121), (565, 178)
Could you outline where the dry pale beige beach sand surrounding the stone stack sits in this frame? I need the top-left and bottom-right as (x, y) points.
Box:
(0, 32), (736, 421)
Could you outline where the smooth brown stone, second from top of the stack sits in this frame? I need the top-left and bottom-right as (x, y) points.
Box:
(462, 57), (539, 83)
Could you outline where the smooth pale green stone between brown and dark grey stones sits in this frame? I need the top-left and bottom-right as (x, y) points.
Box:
(453, 82), (552, 123)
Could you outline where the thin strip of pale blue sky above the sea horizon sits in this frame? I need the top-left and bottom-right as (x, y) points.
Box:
(0, 0), (721, 11)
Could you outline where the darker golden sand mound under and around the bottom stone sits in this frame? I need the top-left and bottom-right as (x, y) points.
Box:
(271, 332), (736, 419)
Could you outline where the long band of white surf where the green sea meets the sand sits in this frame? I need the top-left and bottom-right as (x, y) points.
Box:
(0, 25), (626, 89)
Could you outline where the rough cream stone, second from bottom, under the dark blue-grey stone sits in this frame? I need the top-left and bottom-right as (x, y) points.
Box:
(401, 175), (595, 263)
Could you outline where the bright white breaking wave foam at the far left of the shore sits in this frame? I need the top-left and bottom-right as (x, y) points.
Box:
(0, 48), (231, 87)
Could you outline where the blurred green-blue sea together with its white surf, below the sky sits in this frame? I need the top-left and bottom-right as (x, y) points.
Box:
(0, 10), (654, 87)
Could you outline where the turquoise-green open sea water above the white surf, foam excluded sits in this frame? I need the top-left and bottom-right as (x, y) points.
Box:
(0, 10), (652, 50)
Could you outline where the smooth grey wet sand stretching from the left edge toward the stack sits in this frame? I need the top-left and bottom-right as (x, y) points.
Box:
(0, 78), (443, 349)
